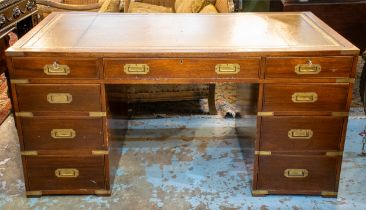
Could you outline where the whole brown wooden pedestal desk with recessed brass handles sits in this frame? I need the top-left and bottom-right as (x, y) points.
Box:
(6, 12), (359, 196)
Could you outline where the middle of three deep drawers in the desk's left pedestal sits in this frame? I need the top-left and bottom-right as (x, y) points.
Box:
(20, 117), (104, 150)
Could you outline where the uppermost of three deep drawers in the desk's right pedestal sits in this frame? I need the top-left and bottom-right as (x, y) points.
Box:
(263, 84), (349, 112)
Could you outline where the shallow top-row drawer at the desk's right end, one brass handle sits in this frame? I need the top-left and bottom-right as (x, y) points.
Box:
(265, 57), (353, 78)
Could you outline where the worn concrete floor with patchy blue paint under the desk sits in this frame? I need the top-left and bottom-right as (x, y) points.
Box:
(0, 116), (366, 210)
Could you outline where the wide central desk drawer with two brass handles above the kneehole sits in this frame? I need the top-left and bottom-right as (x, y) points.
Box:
(104, 58), (260, 79)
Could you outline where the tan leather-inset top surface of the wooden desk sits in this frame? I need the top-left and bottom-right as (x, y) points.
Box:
(7, 12), (358, 56)
